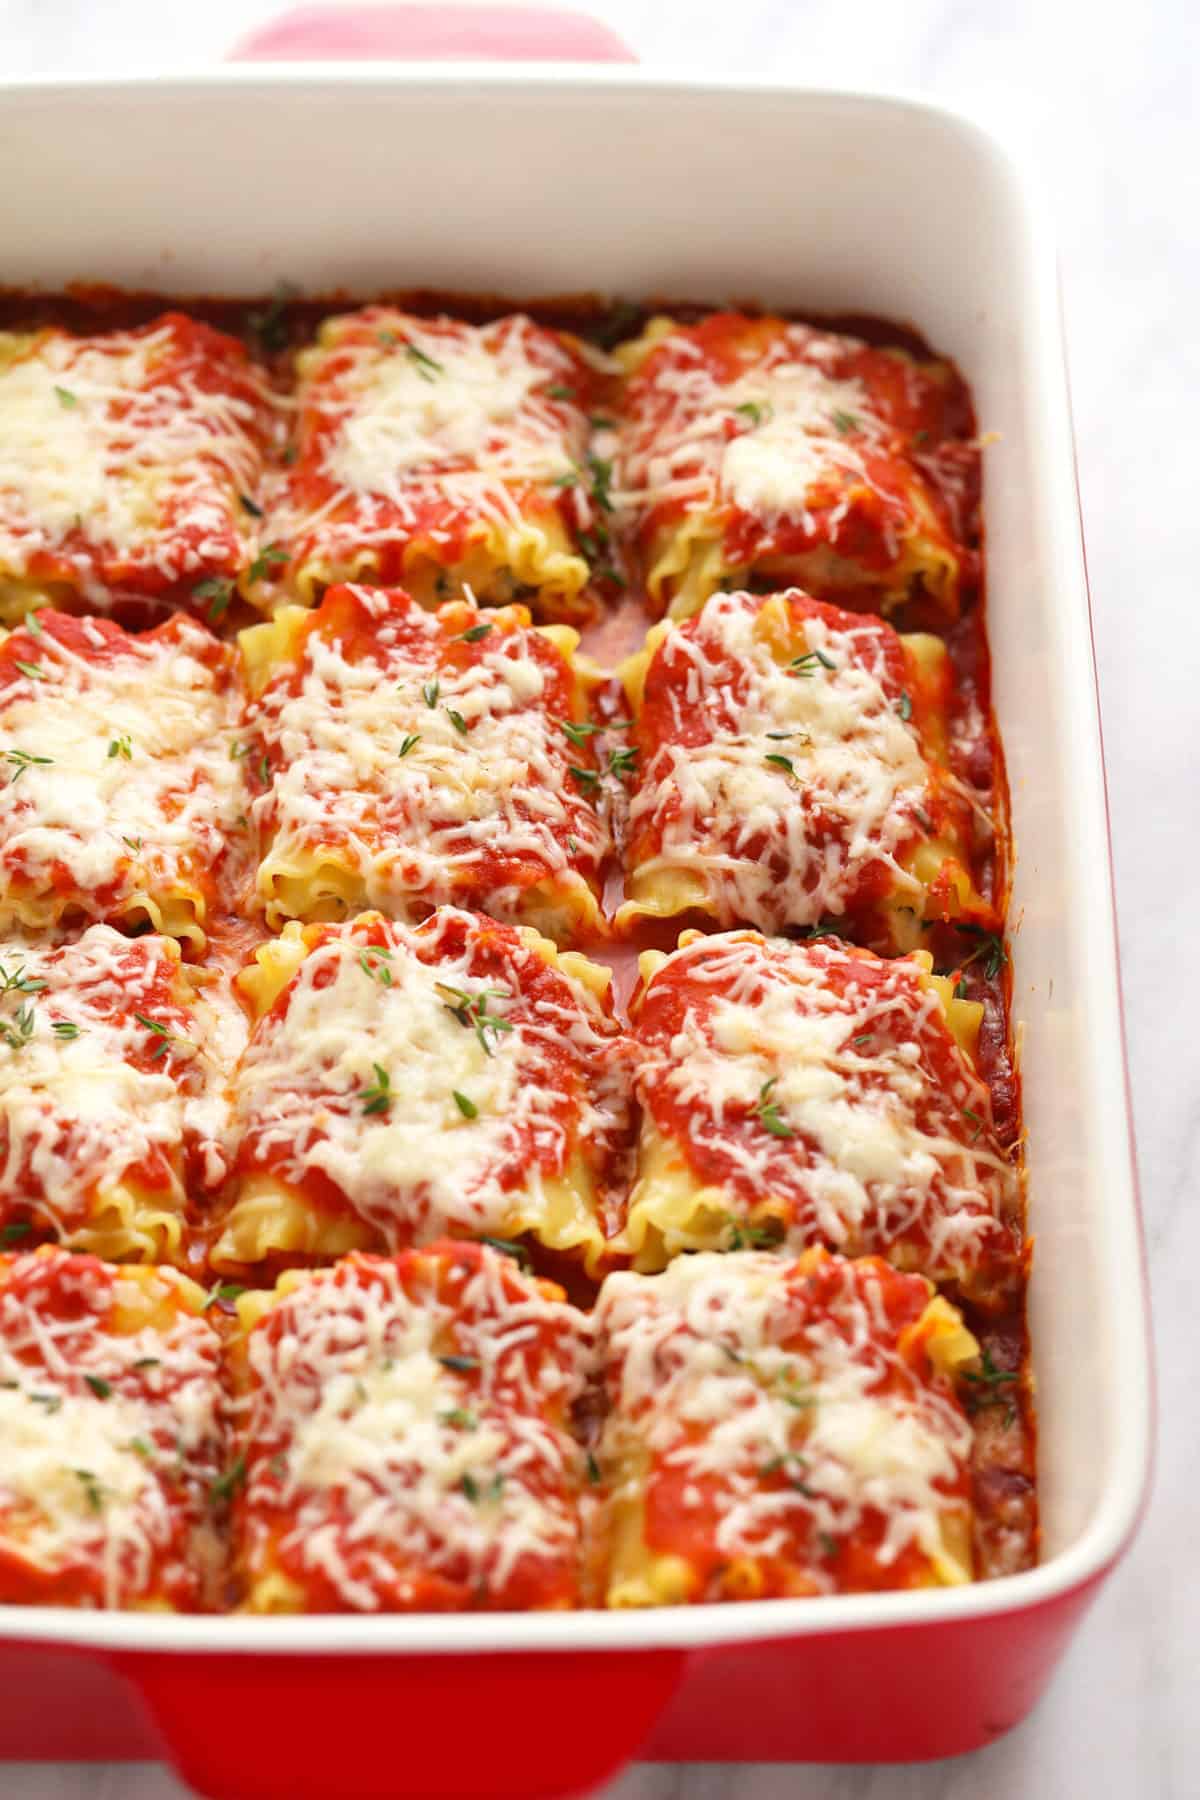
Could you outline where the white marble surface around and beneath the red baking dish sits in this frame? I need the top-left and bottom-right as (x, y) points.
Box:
(0, 0), (1200, 1800)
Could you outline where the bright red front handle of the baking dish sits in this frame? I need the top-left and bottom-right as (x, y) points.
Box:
(120, 1649), (687, 1800)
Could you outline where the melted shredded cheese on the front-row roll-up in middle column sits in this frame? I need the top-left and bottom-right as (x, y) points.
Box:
(245, 1258), (583, 1611)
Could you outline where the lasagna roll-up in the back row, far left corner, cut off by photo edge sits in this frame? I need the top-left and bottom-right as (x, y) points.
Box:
(0, 313), (272, 619)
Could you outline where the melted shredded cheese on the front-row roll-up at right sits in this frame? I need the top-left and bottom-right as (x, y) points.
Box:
(597, 1253), (972, 1586)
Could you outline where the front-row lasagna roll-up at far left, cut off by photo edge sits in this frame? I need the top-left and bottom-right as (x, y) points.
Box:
(0, 1246), (228, 1613)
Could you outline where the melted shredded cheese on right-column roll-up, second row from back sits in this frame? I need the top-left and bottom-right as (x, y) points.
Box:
(630, 594), (928, 931)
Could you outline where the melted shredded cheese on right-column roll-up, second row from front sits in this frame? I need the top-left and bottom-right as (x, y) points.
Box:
(640, 936), (1015, 1278)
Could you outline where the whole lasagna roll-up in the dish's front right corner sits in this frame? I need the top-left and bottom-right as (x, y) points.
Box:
(597, 1249), (977, 1606)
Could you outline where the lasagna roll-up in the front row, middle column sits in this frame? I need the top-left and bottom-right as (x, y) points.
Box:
(232, 1242), (585, 1613)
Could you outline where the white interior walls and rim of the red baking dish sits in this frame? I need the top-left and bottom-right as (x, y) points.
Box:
(0, 65), (1150, 1649)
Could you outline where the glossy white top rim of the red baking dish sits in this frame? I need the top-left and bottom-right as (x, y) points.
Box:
(0, 61), (1153, 1656)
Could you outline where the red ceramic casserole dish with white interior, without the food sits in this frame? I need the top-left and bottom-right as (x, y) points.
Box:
(0, 10), (1150, 1800)
